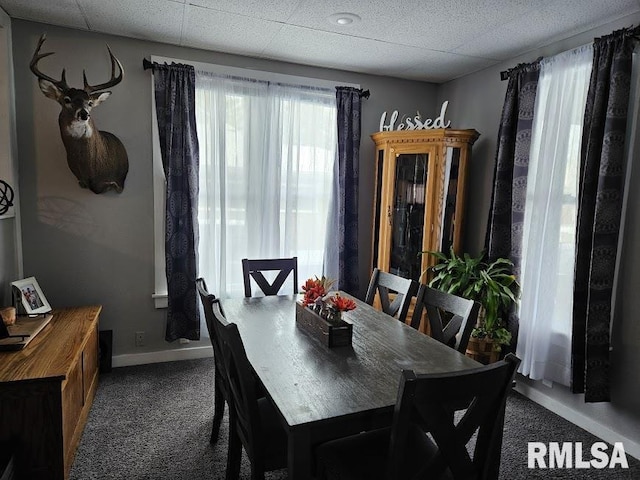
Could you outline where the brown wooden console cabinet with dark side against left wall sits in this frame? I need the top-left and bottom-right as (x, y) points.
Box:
(0, 306), (102, 480)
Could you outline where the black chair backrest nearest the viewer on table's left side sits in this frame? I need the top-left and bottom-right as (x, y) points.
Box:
(219, 323), (266, 462)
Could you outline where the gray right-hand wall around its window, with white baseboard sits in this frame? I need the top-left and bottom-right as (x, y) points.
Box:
(438, 14), (640, 457)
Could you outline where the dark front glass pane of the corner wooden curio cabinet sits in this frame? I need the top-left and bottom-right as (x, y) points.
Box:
(387, 153), (429, 281)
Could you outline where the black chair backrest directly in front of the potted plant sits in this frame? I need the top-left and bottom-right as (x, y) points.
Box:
(411, 285), (480, 353)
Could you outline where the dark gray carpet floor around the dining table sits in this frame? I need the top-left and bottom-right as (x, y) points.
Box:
(70, 358), (640, 480)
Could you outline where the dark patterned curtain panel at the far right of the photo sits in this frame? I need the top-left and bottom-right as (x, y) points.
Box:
(572, 29), (637, 402)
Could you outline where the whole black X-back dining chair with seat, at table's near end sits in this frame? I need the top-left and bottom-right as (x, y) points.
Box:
(317, 354), (520, 480)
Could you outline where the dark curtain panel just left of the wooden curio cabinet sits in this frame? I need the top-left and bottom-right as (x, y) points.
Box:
(336, 87), (363, 295)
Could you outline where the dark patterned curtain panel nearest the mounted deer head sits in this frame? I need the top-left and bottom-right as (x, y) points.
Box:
(153, 63), (200, 342)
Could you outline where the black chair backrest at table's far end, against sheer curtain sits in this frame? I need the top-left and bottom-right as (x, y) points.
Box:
(242, 257), (298, 297)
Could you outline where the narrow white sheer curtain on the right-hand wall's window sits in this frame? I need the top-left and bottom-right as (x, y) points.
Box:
(516, 45), (593, 386)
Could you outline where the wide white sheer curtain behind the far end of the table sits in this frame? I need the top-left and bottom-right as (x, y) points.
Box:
(196, 71), (336, 297)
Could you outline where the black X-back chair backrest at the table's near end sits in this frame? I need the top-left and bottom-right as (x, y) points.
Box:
(387, 354), (520, 480)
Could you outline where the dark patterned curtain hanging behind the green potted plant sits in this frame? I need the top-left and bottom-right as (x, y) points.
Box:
(485, 59), (540, 352)
